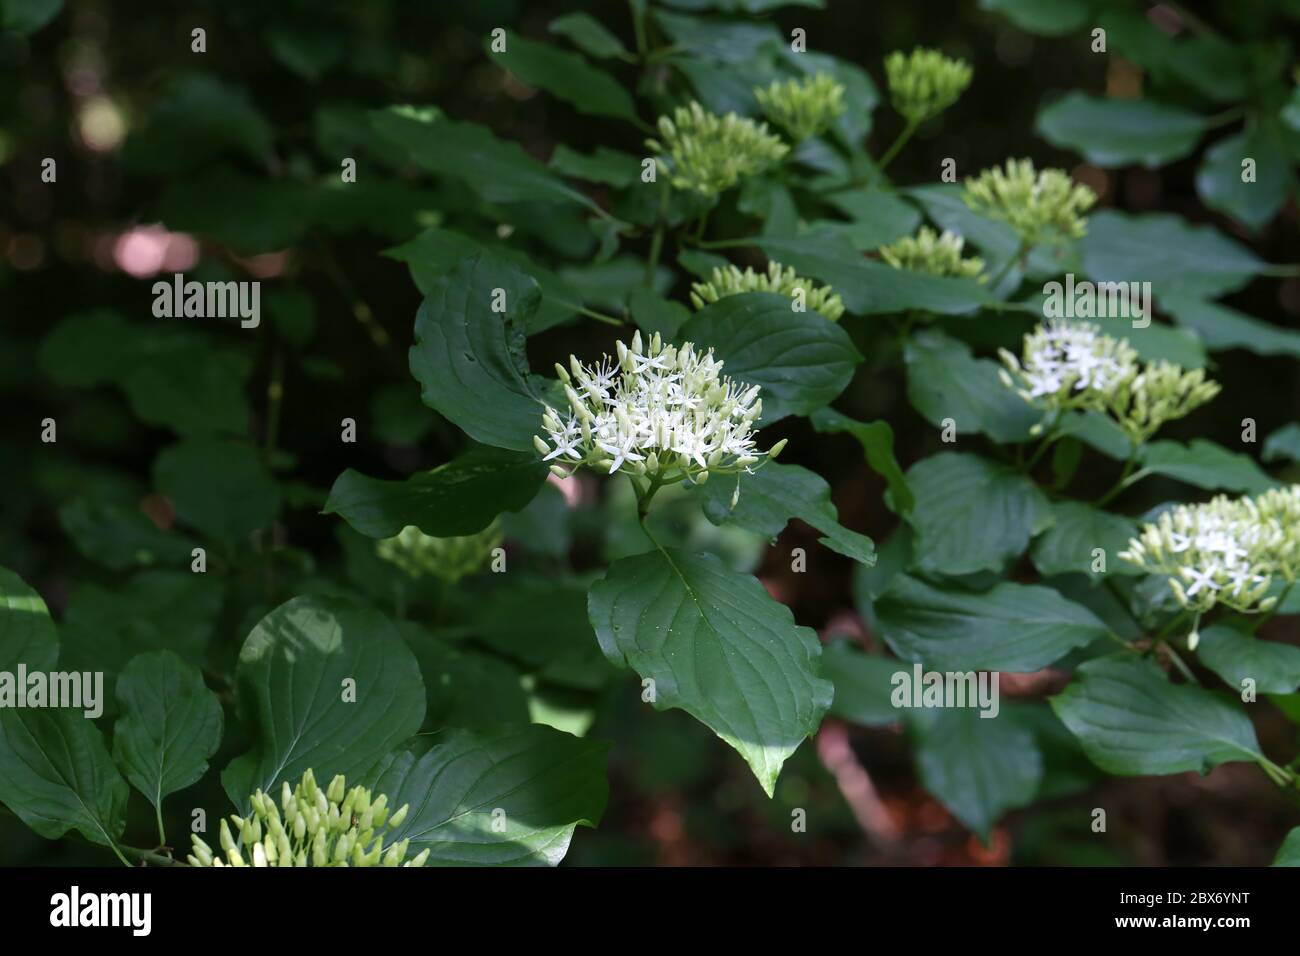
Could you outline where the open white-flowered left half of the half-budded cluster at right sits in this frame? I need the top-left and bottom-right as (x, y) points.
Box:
(1001, 319), (1138, 407)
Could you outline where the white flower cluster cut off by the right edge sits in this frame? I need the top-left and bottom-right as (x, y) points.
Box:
(1119, 485), (1300, 614)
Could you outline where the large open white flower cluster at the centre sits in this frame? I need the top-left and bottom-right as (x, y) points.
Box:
(533, 332), (785, 484)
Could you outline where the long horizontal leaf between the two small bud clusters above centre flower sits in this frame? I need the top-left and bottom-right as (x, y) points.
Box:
(744, 230), (992, 315)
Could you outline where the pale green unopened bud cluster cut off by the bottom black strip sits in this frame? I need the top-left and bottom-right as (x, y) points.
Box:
(186, 770), (429, 866)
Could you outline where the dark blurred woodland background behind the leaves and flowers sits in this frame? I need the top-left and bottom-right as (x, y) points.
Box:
(0, 0), (1300, 865)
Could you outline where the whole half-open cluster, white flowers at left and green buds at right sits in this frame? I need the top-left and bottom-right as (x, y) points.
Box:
(1000, 319), (1219, 445)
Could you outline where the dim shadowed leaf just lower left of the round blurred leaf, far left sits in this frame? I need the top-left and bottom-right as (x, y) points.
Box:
(59, 498), (194, 571)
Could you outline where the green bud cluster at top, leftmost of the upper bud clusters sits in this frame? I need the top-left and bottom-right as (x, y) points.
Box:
(646, 103), (790, 196)
